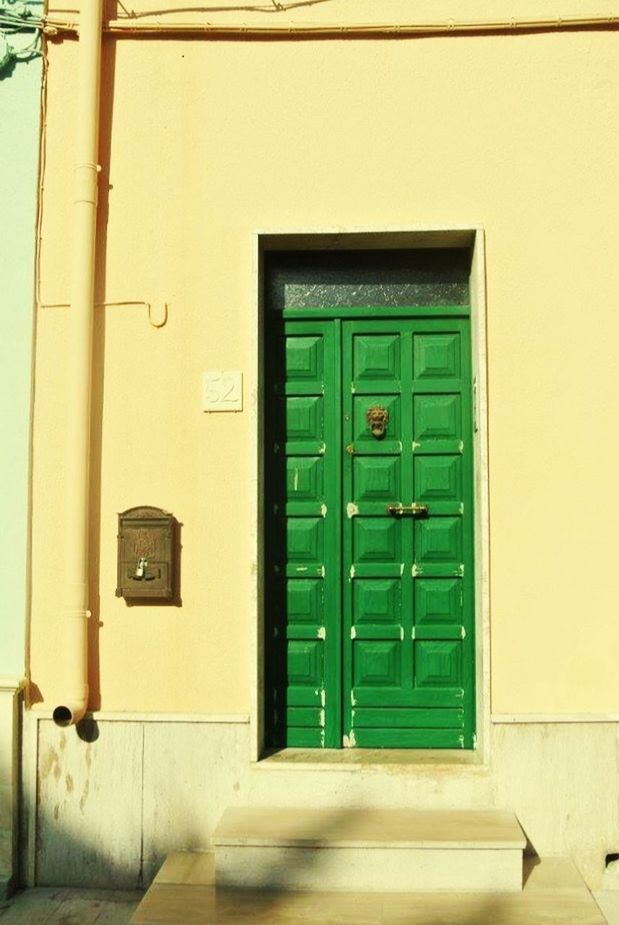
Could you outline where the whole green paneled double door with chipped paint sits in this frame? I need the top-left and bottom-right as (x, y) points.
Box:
(265, 317), (475, 748)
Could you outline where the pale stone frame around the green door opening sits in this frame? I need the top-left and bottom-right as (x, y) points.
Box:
(247, 225), (491, 767)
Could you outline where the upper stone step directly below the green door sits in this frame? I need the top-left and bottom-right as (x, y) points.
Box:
(212, 807), (526, 892)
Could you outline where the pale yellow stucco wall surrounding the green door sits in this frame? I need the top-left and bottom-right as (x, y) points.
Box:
(31, 2), (619, 713)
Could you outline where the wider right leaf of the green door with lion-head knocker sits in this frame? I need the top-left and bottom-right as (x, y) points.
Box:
(342, 319), (473, 748)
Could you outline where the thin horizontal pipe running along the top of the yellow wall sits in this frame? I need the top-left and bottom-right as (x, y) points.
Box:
(44, 15), (619, 38)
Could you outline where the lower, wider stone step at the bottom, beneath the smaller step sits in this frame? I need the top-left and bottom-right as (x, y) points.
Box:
(131, 852), (604, 925)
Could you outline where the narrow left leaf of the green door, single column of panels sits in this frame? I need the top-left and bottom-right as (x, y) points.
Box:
(265, 322), (341, 748)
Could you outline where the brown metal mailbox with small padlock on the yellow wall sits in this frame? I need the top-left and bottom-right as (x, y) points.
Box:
(116, 506), (178, 604)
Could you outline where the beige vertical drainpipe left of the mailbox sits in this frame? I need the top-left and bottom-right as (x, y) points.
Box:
(53, 0), (103, 726)
